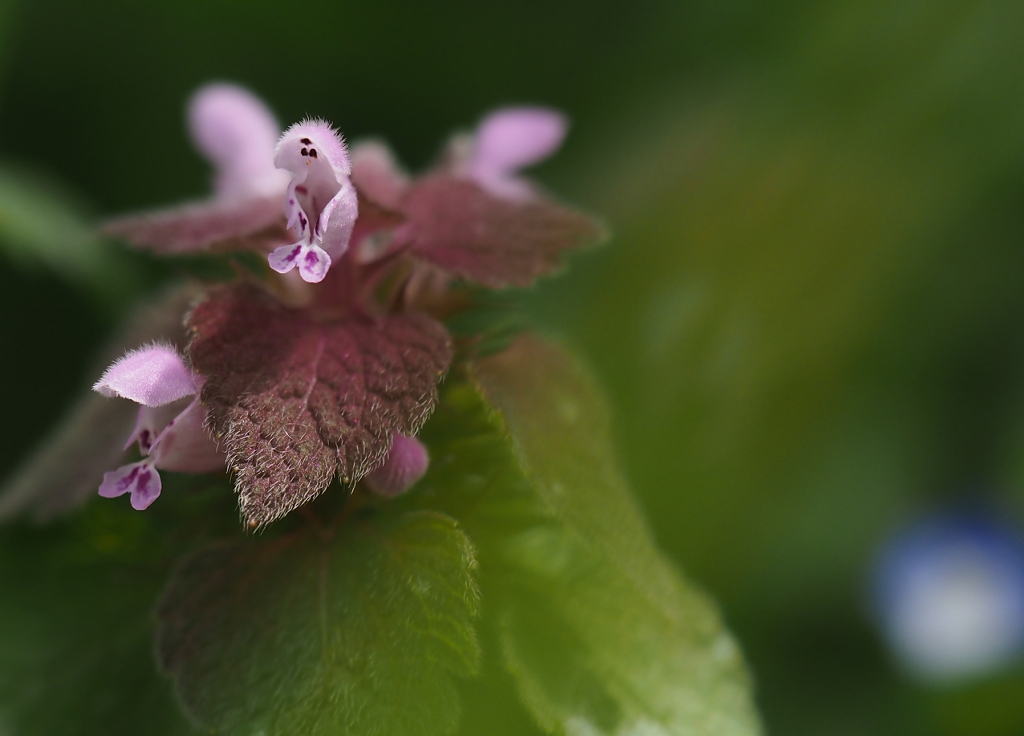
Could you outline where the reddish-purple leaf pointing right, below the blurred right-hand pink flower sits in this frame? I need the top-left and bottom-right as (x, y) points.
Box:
(396, 175), (602, 289)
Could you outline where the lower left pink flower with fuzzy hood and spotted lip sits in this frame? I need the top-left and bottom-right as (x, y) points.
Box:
(93, 344), (224, 511)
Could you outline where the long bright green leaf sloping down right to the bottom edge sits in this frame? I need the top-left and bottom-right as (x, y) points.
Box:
(410, 337), (760, 736)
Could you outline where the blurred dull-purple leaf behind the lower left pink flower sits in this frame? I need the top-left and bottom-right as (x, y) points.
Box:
(0, 286), (199, 521)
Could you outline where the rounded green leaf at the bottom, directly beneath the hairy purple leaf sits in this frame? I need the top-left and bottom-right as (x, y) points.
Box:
(158, 511), (478, 736)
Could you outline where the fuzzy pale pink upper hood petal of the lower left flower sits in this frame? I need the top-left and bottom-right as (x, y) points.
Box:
(92, 343), (196, 406)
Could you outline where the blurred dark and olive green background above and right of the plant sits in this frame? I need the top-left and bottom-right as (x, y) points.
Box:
(0, 0), (1024, 736)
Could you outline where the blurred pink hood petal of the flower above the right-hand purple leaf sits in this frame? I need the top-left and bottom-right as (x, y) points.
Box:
(469, 107), (568, 183)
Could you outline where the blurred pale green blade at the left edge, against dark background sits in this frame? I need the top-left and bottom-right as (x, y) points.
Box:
(0, 166), (138, 304)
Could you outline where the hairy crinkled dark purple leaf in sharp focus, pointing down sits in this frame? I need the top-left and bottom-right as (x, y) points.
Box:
(189, 286), (452, 525)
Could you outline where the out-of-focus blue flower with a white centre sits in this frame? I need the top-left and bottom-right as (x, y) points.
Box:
(873, 513), (1024, 684)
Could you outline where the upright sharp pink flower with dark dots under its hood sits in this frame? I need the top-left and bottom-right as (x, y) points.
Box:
(269, 120), (358, 284)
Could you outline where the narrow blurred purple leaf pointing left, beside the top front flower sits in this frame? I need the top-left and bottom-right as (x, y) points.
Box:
(100, 189), (291, 254)
